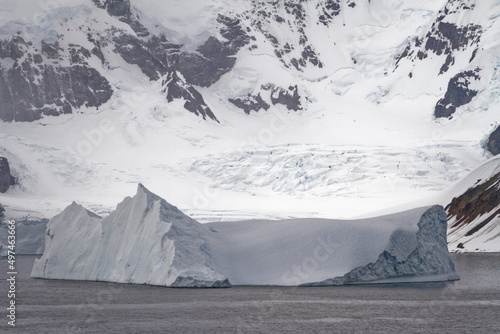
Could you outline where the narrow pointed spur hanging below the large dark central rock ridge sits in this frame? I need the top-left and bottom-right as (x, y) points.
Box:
(162, 72), (218, 122)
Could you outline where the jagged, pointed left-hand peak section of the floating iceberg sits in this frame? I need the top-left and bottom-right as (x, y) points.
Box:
(32, 184), (229, 287)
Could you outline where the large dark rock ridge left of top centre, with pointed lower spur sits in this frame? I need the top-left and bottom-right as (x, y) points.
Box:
(96, 0), (238, 121)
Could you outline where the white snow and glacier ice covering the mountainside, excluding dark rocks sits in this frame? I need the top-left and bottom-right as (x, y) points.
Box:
(0, 0), (500, 250)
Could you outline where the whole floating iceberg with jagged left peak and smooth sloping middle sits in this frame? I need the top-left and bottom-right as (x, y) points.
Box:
(31, 184), (458, 287)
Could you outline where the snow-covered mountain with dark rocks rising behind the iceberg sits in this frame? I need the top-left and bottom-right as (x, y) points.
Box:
(0, 0), (500, 250)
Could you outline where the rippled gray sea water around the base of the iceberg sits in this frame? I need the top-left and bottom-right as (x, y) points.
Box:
(0, 253), (500, 334)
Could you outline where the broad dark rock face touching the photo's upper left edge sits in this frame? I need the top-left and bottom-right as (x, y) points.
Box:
(0, 36), (113, 122)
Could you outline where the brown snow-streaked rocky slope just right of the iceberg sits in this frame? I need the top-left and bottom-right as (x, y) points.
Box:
(446, 173), (500, 236)
